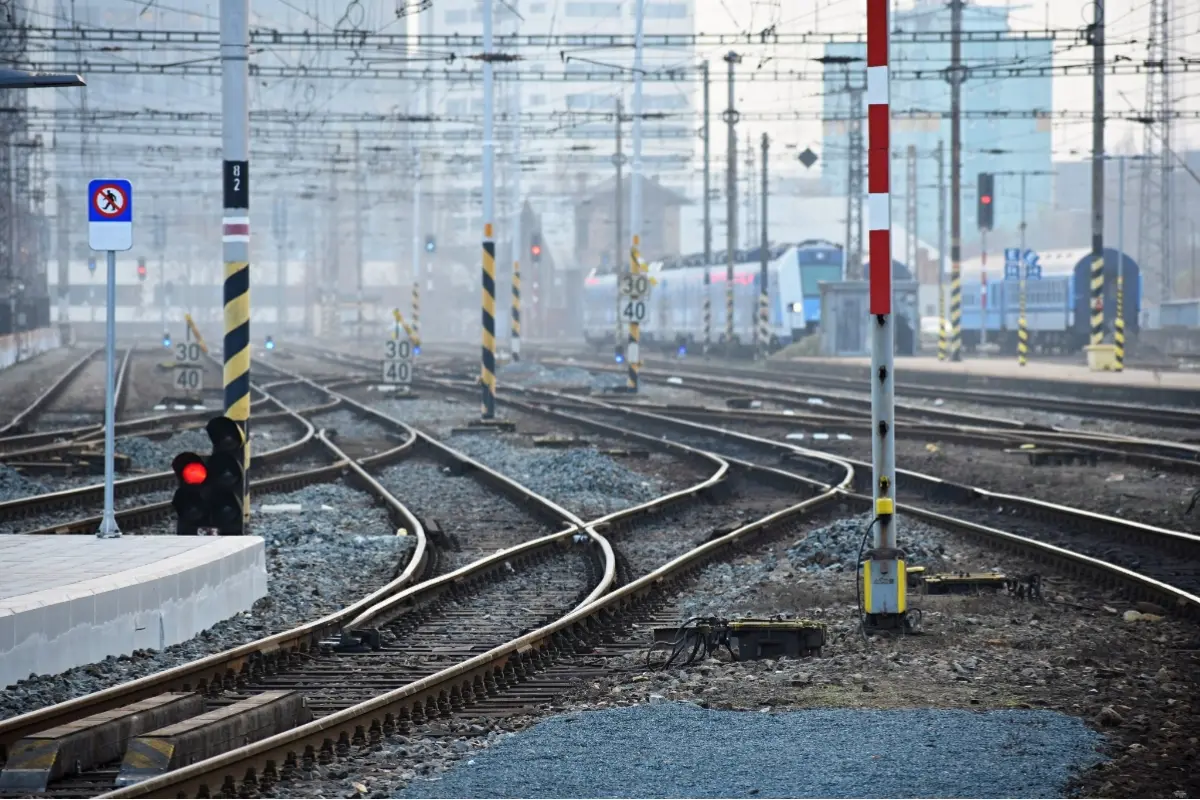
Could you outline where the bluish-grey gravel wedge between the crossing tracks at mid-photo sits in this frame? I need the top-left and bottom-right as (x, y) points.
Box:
(450, 434), (664, 519)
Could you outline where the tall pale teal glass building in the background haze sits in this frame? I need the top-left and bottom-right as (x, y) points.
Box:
(818, 0), (1054, 266)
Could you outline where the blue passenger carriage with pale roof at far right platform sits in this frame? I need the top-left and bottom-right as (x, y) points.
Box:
(934, 248), (1141, 353)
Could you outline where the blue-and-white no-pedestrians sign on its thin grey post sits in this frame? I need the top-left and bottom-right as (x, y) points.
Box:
(88, 179), (133, 539)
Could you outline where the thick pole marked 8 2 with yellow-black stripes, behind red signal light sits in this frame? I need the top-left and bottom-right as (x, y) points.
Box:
(221, 0), (251, 533)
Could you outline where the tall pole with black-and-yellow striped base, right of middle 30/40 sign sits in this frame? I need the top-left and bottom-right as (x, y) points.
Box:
(480, 0), (496, 420)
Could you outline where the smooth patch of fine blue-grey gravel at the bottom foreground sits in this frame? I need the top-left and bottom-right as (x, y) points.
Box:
(397, 703), (1103, 798)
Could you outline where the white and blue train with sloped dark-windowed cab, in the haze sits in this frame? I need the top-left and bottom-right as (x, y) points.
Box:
(583, 245), (805, 349)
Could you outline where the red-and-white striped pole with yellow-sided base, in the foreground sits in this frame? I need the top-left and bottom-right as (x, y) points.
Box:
(862, 0), (906, 628)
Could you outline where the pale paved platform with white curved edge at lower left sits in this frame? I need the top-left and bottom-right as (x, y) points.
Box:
(0, 535), (266, 686)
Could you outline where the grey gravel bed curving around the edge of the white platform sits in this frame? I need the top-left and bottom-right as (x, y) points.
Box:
(0, 483), (414, 718)
